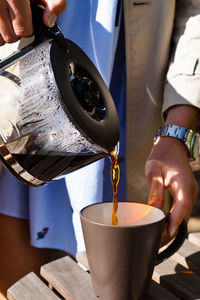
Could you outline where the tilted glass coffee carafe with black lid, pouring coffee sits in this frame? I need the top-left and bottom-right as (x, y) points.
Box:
(0, 7), (119, 186)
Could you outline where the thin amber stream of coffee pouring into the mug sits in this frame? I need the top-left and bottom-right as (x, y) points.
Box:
(110, 150), (120, 225)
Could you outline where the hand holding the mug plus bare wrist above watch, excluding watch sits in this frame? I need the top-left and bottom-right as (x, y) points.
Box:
(145, 105), (200, 244)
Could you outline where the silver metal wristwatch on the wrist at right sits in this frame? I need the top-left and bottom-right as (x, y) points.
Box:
(154, 124), (200, 160)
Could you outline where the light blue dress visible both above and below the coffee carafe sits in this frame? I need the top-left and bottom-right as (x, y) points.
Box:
(0, 0), (125, 255)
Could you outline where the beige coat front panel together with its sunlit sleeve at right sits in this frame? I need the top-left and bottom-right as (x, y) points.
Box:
(124, 0), (200, 202)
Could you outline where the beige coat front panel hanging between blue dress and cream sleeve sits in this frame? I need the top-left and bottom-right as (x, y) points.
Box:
(124, 0), (175, 202)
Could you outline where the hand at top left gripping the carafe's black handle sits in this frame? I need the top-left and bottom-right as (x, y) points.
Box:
(0, 0), (66, 46)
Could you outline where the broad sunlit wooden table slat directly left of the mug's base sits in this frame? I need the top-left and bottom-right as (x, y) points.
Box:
(41, 256), (98, 300)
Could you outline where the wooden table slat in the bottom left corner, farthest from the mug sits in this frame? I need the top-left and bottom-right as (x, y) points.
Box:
(7, 272), (60, 300)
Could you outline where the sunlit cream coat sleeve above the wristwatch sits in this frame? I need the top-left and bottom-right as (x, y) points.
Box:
(162, 0), (200, 113)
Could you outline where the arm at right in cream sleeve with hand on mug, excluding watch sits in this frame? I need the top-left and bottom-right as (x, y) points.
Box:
(146, 1), (200, 241)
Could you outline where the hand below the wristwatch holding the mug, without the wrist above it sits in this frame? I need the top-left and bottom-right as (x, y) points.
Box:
(145, 138), (199, 247)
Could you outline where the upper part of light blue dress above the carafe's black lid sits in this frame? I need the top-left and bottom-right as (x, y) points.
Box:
(57, 0), (119, 86)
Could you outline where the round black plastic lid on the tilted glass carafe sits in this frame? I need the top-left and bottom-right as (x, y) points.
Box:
(50, 39), (120, 151)
